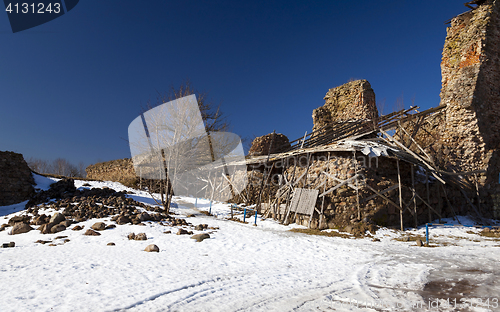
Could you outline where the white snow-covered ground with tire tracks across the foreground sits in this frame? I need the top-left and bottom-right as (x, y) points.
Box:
(0, 177), (500, 312)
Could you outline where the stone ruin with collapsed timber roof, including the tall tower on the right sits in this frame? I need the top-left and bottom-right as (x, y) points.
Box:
(239, 0), (500, 229)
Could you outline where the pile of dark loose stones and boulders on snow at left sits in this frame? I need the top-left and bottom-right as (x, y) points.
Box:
(0, 179), (217, 251)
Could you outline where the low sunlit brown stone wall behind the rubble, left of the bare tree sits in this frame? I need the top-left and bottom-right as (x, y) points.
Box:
(85, 158), (137, 184)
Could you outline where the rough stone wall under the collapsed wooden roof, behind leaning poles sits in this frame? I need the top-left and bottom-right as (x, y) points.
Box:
(246, 152), (446, 229)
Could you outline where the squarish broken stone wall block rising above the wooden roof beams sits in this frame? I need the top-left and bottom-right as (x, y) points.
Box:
(312, 79), (378, 131)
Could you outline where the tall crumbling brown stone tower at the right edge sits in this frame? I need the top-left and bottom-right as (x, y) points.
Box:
(438, 0), (500, 218)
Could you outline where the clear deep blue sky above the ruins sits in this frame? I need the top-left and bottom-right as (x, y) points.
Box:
(0, 0), (467, 168)
